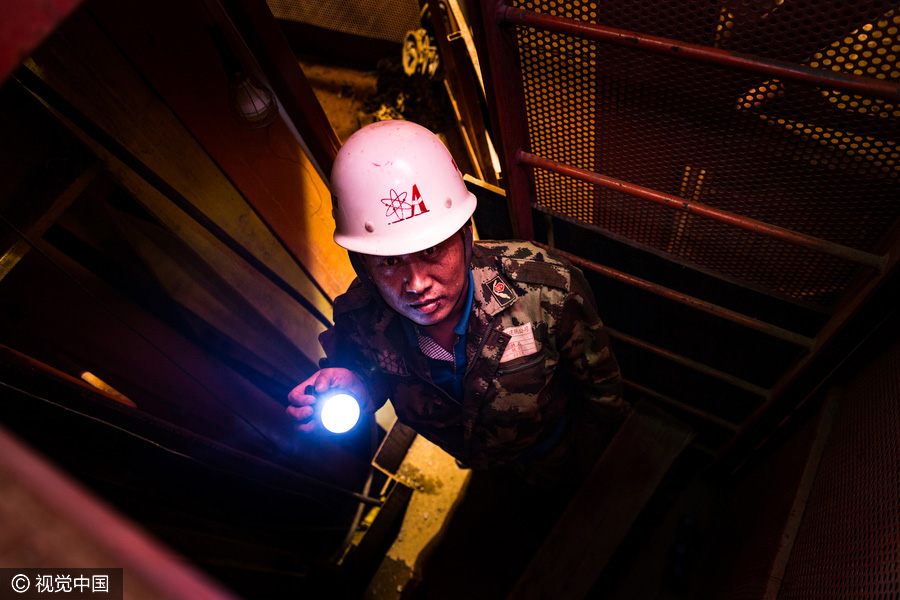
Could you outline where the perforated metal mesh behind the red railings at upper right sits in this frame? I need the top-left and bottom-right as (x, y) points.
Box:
(514, 0), (900, 306)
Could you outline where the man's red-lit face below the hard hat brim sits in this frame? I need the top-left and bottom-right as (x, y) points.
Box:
(362, 233), (468, 327)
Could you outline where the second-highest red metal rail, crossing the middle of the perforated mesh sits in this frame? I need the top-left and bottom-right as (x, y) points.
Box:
(516, 150), (888, 271)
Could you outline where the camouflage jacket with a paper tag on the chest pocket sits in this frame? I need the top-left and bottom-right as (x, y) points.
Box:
(320, 241), (628, 468)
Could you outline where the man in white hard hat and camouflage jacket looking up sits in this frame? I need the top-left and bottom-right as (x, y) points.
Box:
(288, 121), (628, 482)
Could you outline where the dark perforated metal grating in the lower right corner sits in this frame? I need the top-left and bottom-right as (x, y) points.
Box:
(778, 343), (900, 600)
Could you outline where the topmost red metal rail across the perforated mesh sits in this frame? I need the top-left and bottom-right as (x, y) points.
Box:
(500, 6), (900, 102)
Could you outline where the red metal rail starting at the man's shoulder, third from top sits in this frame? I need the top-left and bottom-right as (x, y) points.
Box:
(535, 242), (814, 348)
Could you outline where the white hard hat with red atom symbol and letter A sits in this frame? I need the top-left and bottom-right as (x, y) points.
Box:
(331, 120), (476, 256)
